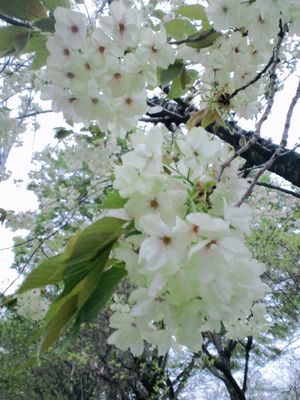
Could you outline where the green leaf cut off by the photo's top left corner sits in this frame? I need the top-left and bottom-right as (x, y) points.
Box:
(0, 0), (47, 21)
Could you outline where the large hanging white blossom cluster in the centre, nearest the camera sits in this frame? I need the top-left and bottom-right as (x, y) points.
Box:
(109, 127), (267, 355)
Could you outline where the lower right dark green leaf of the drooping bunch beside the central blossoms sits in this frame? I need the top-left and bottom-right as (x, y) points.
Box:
(75, 264), (127, 325)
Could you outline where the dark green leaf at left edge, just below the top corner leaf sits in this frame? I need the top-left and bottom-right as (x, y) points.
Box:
(0, 26), (31, 57)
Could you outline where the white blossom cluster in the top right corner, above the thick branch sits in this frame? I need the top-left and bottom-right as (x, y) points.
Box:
(178, 0), (300, 118)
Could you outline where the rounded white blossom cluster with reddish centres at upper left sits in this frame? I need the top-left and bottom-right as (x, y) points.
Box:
(42, 1), (175, 135)
